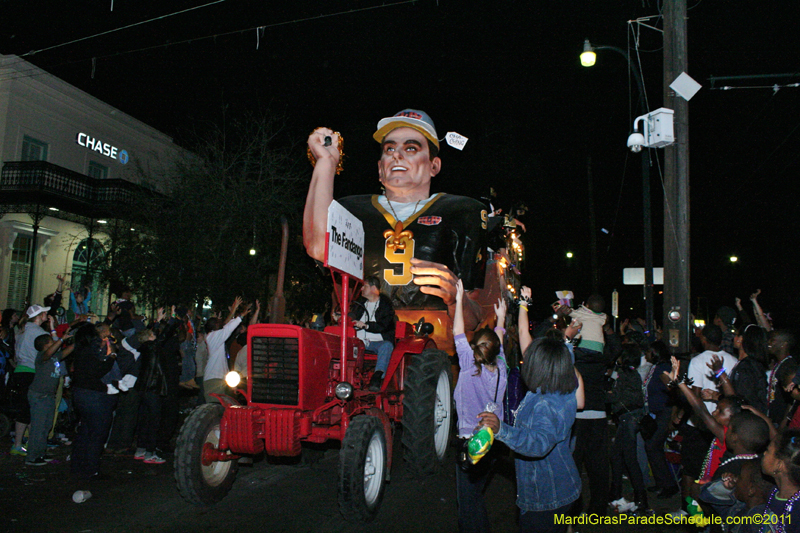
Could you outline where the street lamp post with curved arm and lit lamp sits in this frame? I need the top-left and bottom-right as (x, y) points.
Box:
(581, 39), (654, 331)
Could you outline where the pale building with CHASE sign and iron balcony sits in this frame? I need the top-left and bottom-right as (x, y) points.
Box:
(0, 55), (184, 316)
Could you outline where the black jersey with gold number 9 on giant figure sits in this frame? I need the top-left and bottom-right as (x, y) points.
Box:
(337, 193), (487, 309)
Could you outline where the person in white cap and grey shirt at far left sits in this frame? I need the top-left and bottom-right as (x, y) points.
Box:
(11, 305), (55, 456)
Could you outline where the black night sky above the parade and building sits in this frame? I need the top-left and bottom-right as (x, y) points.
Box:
(0, 0), (800, 326)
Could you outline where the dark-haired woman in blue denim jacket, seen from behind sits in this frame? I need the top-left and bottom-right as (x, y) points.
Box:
(480, 337), (581, 533)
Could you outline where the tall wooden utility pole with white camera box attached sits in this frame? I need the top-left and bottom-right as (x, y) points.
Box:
(663, 0), (691, 353)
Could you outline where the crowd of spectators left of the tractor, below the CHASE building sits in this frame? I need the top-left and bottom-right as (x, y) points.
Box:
(0, 276), (253, 480)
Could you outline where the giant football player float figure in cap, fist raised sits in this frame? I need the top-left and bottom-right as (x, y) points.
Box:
(303, 109), (491, 348)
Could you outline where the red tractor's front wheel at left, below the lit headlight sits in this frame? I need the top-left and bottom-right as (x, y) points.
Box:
(175, 404), (239, 505)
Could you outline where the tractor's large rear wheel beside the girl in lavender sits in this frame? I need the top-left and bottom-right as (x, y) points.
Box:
(402, 350), (453, 476)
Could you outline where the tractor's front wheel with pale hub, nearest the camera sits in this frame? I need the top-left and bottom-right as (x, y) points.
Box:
(339, 415), (388, 522)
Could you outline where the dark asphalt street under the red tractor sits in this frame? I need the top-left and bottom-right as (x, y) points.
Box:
(0, 416), (690, 533)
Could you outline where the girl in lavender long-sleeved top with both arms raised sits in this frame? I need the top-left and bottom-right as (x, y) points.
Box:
(453, 280), (508, 532)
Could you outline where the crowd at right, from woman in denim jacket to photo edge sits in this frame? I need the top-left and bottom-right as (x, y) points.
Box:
(459, 288), (800, 533)
